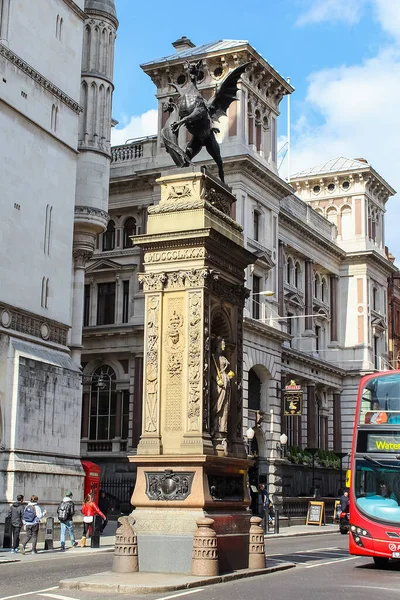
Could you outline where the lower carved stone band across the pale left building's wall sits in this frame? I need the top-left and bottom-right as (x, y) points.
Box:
(0, 303), (68, 346)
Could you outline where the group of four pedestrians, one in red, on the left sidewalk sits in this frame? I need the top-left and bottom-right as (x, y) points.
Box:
(8, 490), (108, 554)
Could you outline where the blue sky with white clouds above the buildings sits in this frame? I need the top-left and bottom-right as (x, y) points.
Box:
(113, 0), (400, 262)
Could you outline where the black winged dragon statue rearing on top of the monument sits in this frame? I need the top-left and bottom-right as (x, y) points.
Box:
(161, 60), (250, 181)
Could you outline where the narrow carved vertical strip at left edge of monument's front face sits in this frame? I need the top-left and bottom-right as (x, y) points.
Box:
(144, 296), (160, 433)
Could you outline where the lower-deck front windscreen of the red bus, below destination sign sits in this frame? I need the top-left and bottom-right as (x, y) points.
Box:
(355, 456), (400, 526)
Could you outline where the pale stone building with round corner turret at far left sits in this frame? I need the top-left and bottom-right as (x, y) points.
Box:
(0, 0), (117, 523)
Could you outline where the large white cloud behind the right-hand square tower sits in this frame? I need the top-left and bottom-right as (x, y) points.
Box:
(282, 47), (400, 261)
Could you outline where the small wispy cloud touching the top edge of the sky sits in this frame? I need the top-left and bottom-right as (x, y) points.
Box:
(296, 0), (368, 26)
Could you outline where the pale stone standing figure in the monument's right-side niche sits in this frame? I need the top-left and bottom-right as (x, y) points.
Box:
(210, 337), (235, 438)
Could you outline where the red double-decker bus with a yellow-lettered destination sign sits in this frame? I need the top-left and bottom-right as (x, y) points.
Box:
(349, 371), (400, 567)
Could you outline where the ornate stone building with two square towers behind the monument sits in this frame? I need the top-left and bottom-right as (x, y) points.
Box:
(82, 38), (394, 499)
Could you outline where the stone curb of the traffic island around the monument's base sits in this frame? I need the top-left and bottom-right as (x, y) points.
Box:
(58, 562), (296, 594)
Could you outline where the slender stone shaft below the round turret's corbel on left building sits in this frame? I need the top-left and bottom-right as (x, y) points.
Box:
(70, 250), (92, 366)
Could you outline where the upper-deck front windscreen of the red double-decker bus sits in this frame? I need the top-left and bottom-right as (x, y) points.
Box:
(358, 373), (400, 425)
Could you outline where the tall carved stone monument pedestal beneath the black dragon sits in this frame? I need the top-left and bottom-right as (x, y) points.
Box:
(129, 170), (255, 573)
